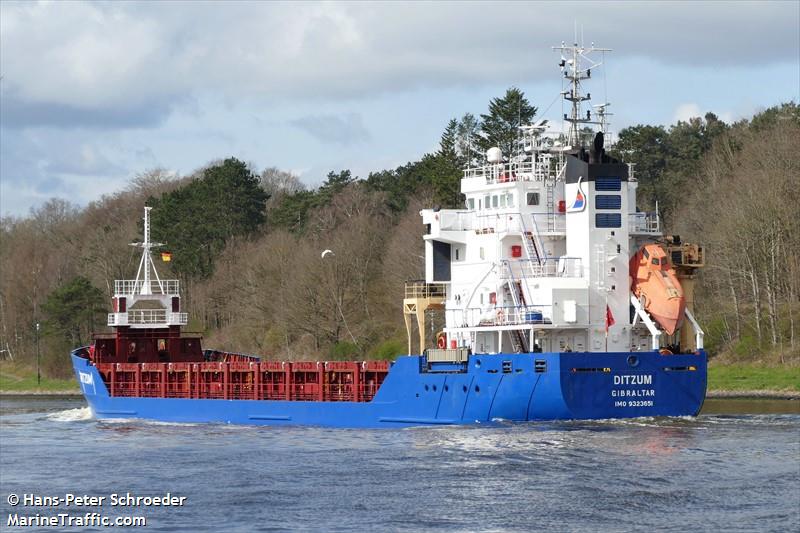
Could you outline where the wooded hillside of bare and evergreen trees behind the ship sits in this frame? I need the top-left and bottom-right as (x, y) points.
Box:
(0, 88), (800, 378)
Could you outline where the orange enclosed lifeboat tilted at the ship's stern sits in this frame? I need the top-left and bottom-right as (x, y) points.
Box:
(630, 244), (686, 335)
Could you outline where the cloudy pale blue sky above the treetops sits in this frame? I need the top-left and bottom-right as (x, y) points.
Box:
(0, 0), (800, 216)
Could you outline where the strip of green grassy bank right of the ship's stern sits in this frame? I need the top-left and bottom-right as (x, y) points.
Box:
(708, 364), (800, 392)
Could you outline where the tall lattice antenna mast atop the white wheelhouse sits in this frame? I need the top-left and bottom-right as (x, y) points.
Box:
(553, 41), (611, 148)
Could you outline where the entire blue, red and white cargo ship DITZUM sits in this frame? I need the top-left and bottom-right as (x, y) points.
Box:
(71, 44), (706, 428)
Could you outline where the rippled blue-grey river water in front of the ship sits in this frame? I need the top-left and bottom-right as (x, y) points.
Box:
(0, 397), (800, 532)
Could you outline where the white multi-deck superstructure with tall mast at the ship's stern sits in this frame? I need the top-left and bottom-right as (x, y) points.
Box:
(420, 45), (694, 353)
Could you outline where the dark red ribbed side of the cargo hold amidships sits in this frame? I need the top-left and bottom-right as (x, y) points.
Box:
(96, 359), (390, 402)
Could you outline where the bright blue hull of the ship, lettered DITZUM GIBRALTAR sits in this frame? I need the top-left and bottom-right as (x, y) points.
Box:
(72, 350), (706, 428)
